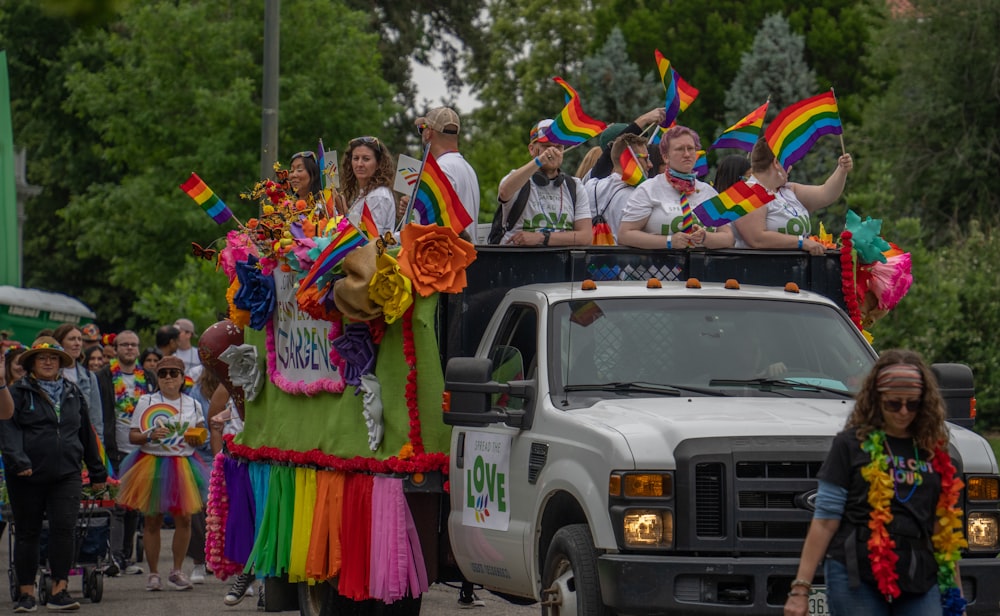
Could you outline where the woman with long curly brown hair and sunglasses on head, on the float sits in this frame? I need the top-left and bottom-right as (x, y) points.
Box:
(340, 137), (396, 235)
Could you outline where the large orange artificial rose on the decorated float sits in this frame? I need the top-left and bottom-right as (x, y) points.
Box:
(399, 223), (476, 297)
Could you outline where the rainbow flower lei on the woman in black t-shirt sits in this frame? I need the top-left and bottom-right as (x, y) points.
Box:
(861, 430), (968, 616)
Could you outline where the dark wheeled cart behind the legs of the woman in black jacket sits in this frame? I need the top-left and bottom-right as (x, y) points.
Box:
(3, 493), (115, 605)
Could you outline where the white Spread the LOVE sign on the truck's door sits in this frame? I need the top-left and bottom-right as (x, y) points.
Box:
(462, 432), (511, 530)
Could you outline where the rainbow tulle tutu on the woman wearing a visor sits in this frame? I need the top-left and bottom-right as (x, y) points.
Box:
(118, 450), (208, 515)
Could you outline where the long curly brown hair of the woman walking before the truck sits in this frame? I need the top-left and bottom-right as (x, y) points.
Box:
(845, 349), (948, 451)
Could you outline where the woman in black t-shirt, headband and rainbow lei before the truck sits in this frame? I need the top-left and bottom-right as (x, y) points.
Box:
(785, 350), (965, 616)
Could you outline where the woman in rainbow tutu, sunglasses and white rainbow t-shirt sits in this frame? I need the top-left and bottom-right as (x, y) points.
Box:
(118, 356), (208, 591)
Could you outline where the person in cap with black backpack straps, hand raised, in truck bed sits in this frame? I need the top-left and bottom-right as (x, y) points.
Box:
(489, 119), (592, 246)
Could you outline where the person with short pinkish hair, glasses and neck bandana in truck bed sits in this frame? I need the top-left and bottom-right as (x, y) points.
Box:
(618, 126), (733, 248)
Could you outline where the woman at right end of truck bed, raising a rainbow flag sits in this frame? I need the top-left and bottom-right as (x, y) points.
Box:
(733, 138), (854, 255)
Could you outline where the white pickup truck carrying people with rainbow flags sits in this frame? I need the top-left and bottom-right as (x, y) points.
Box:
(441, 249), (1000, 615)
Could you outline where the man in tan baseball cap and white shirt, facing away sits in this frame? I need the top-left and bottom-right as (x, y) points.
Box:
(415, 107), (479, 235)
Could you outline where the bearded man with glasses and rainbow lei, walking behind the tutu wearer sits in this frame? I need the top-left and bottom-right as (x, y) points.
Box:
(97, 330), (157, 576)
